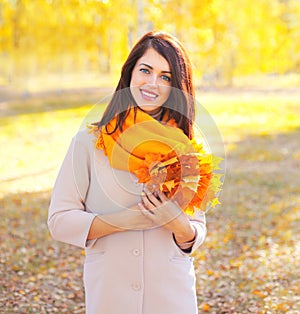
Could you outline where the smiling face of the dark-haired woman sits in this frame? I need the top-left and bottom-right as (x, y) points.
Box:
(130, 48), (172, 114)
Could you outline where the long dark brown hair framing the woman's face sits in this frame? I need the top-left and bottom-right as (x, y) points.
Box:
(95, 32), (195, 139)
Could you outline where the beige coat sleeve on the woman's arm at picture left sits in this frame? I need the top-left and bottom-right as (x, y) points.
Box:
(48, 132), (95, 248)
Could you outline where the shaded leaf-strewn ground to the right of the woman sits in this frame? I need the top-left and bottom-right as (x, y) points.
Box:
(195, 131), (300, 314)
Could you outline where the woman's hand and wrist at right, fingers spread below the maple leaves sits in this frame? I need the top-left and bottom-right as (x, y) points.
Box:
(138, 189), (195, 245)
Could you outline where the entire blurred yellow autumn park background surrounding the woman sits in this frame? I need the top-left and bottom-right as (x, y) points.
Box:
(0, 0), (300, 313)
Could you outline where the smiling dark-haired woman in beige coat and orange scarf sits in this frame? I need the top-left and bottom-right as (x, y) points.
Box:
(48, 32), (206, 314)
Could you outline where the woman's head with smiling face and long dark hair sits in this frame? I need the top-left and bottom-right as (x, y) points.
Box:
(97, 33), (195, 139)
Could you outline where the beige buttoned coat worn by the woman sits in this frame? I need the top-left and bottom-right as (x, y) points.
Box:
(48, 130), (206, 314)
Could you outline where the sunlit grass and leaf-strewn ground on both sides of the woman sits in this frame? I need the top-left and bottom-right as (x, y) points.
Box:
(0, 89), (300, 313)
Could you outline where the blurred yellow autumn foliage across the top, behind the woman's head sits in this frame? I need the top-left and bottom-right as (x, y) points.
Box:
(0, 0), (300, 85)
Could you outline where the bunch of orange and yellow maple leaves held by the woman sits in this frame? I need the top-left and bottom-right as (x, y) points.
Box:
(135, 142), (222, 215)
